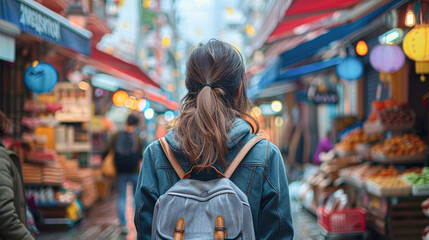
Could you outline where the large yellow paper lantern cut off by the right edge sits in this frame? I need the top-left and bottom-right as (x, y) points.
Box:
(403, 24), (429, 82)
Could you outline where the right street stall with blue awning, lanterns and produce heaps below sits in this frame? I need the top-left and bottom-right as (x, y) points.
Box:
(249, 1), (429, 239)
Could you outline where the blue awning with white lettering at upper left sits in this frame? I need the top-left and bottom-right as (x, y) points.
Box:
(0, 0), (92, 56)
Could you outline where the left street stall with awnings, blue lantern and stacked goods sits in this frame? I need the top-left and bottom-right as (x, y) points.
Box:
(0, 0), (177, 230)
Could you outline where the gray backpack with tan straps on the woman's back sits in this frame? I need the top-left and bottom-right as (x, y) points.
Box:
(152, 137), (262, 240)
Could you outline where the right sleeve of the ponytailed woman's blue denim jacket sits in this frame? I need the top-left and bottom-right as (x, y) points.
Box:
(259, 143), (294, 240)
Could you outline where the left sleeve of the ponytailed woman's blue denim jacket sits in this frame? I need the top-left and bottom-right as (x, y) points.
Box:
(134, 144), (159, 240)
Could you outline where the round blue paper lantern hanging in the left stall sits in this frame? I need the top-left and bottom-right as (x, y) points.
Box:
(24, 61), (58, 93)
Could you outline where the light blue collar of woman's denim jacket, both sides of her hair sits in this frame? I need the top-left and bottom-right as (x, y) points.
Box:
(165, 118), (251, 150)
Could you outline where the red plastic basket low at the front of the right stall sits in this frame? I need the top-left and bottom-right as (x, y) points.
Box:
(317, 207), (366, 233)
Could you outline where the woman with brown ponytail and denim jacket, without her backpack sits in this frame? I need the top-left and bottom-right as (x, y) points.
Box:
(134, 40), (293, 239)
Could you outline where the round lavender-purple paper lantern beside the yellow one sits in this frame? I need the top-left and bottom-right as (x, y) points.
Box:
(369, 44), (405, 73)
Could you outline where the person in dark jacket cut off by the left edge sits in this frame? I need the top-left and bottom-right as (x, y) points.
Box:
(0, 111), (33, 240)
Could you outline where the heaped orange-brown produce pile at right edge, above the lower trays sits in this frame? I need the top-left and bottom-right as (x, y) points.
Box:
(372, 134), (428, 156)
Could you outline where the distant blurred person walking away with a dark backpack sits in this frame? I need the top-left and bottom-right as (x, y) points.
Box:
(103, 114), (145, 234)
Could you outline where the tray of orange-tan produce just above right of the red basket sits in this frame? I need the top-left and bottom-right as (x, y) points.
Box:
(365, 176), (411, 197)
